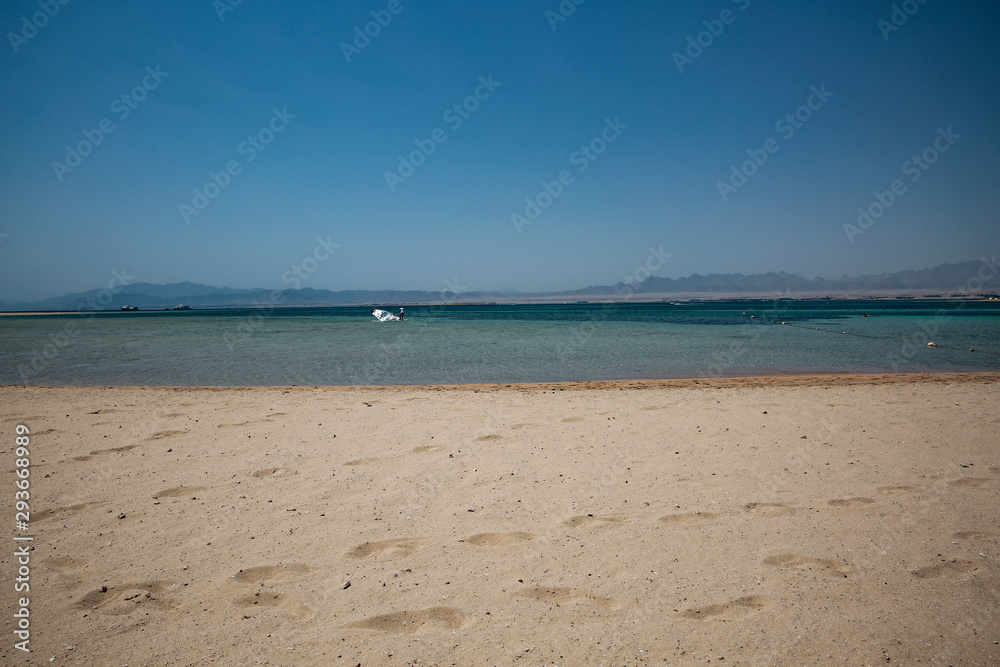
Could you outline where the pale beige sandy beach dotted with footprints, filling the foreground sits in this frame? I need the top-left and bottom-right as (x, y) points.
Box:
(0, 374), (1000, 667)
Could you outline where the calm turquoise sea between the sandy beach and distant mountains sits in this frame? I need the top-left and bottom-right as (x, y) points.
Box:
(0, 300), (1000, 386)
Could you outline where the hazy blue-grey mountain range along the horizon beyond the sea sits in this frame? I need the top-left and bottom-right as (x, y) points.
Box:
(0, 261), (1000, 312)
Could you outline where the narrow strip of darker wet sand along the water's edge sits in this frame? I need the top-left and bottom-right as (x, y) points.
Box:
(0, 371), (1000, 392)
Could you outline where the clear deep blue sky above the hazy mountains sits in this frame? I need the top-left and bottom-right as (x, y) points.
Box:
(0, 0), (1000, 301)
